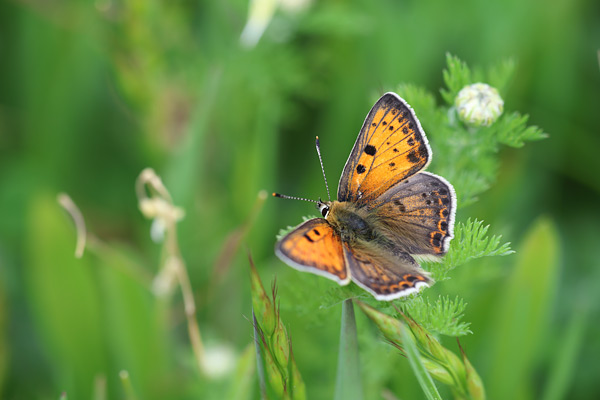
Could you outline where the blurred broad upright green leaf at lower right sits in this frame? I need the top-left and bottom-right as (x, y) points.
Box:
(488, 217), (560, 399)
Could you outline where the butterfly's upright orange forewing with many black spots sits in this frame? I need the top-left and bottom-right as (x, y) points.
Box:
(338, 93), (431, 204)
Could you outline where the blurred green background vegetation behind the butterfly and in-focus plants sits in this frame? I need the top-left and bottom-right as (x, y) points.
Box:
(0, 0), (600, 399)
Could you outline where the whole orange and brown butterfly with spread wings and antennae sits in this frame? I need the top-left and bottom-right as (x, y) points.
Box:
(273, 92), (456, 300)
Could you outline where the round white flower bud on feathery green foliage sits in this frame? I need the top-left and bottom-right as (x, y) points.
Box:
(454, 83), (504, 126)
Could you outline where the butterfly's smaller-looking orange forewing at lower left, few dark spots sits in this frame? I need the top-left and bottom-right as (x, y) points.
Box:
(275, 218), (350, 285)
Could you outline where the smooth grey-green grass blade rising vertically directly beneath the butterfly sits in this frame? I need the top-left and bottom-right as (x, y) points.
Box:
(334, 299), (363, 400)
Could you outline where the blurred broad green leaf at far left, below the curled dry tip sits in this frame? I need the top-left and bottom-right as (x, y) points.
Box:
(23, 193), (107, 398)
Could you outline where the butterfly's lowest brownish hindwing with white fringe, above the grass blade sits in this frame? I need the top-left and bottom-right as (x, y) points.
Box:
(344, 244), (431, 300)
